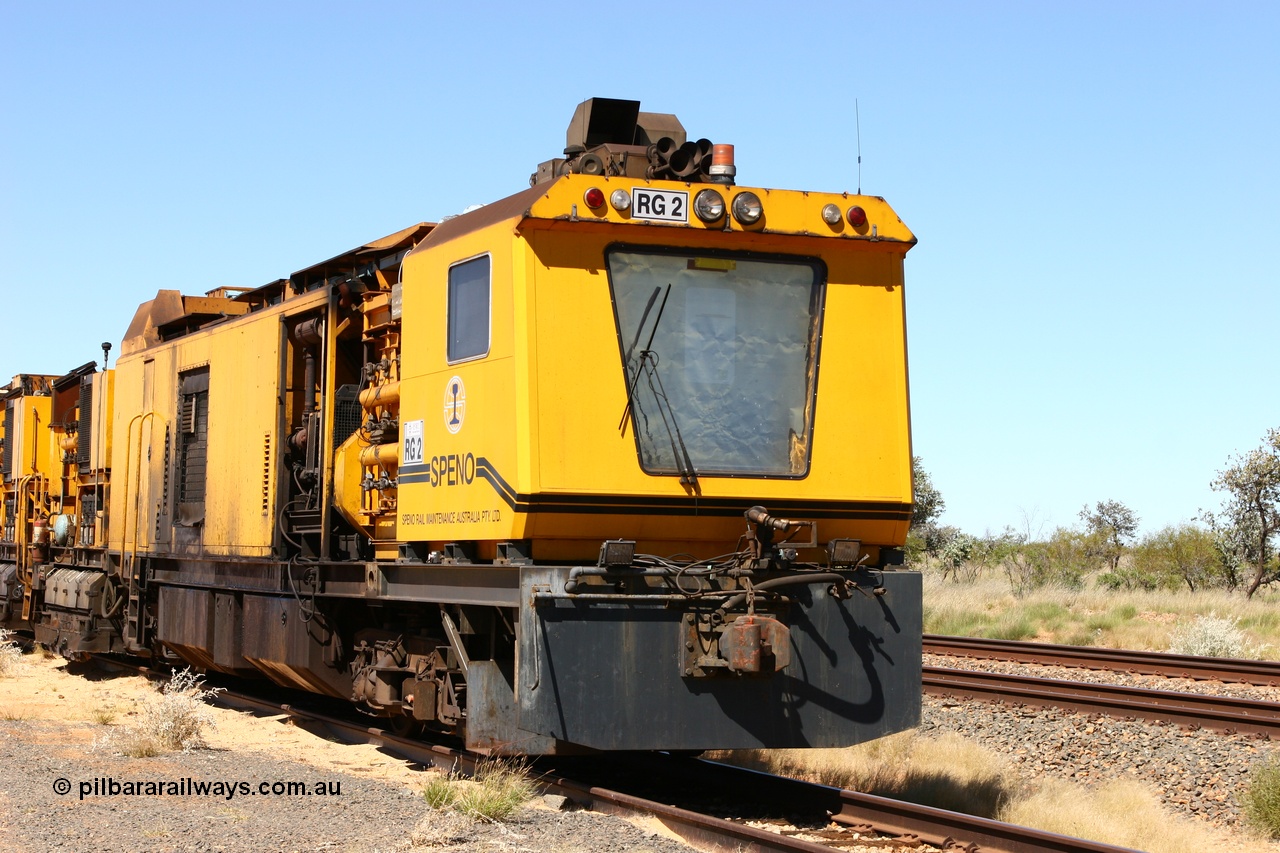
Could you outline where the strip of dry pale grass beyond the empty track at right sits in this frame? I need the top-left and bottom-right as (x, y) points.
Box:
(924, 570), (1280, 657)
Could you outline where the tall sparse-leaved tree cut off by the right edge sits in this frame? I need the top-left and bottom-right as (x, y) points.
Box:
(1212, 429), (1280, 598)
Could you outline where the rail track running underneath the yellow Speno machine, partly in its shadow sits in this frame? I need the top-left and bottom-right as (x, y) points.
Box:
(94, 658), (1135, 853)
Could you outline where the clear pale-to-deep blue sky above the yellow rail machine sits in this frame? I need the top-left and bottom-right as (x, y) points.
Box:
(0, 1), (1280, 533)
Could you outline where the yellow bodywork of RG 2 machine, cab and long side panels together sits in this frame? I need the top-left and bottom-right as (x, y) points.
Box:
(82, 175), (914, 560)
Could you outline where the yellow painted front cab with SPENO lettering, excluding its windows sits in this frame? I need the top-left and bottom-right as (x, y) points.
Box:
(398, 175), (914, 560)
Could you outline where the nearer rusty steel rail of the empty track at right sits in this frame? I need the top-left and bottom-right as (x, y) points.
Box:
(923, 666), (1280, 739)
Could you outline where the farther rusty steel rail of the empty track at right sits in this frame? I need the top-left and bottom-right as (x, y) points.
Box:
(924, 634), (1280, 686)
